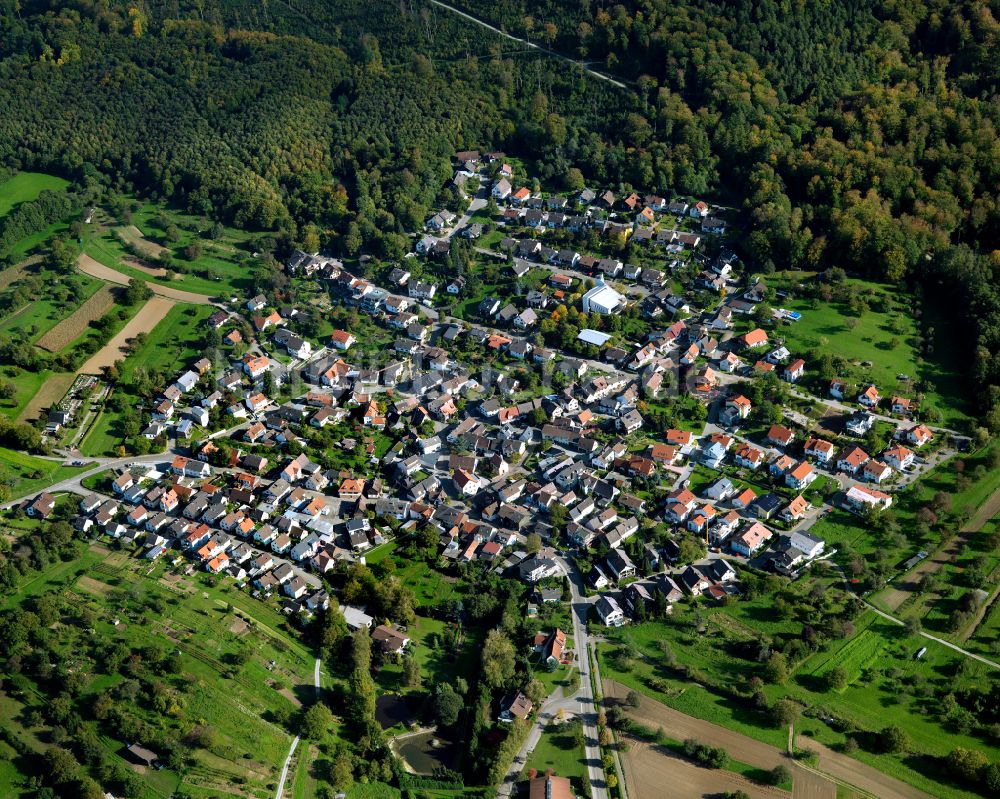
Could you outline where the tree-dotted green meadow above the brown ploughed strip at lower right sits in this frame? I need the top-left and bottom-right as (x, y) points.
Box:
(598, 608), (1000, 799)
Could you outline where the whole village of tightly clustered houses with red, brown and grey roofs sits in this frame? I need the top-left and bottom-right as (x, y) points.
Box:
(26, 152), (951, 664)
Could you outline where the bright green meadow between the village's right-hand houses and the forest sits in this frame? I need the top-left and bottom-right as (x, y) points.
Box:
(766, 272), (970, 426)
